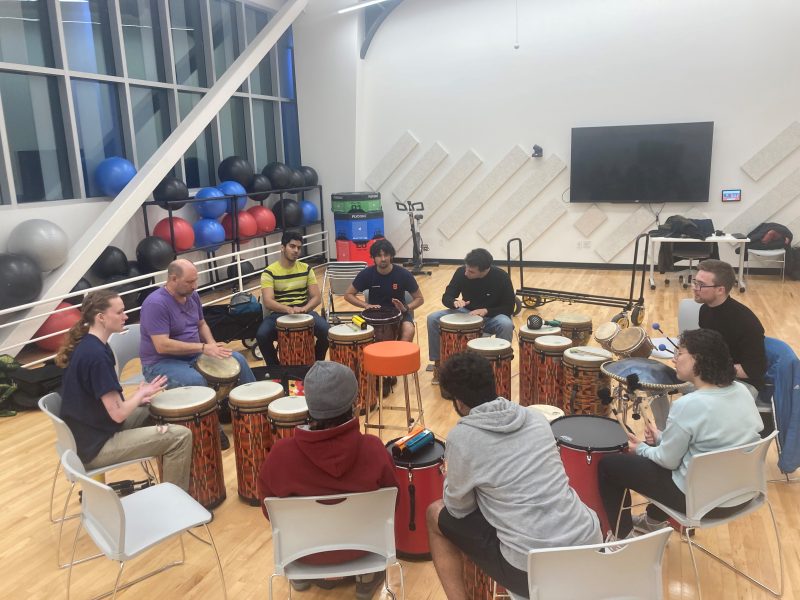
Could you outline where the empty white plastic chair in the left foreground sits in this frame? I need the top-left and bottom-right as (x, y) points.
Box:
(61, 450), (227, 600)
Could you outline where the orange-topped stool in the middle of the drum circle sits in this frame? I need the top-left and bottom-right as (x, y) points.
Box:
(363, 341), (425, 436)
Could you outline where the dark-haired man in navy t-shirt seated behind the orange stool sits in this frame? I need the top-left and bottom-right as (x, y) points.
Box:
(344, 239), (425, 342)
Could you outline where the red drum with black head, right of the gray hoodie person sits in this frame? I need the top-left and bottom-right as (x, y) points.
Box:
(550, 415), (628, 535)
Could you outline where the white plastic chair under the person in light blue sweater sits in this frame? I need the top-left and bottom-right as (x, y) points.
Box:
(650, 431), (783, 598)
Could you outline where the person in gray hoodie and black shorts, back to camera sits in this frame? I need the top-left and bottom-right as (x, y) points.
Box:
(427, 352), (602, 600)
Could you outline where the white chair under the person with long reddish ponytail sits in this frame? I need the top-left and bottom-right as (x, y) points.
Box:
(39, 392), (157, 569)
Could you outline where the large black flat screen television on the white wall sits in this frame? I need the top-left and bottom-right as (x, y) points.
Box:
(570, 121), (714, 202)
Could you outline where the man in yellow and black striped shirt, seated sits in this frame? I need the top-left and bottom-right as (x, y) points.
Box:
(256, 231), (328, 365)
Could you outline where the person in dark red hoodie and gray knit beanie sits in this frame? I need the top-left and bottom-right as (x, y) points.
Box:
(258, 360), (398, 600)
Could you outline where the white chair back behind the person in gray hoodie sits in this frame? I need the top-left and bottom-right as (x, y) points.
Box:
(528, 527), (672, 600)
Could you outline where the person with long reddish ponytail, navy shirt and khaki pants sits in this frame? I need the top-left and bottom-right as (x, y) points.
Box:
(56, 290), (192, 491)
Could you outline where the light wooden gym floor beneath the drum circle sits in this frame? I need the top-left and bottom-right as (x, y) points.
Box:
(0, 267), (800, 600)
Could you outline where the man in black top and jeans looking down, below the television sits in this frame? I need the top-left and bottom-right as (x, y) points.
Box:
(428, 248), (516, 384)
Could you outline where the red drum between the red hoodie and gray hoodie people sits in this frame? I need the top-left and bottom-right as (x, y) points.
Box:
(386, 438), (444, 558)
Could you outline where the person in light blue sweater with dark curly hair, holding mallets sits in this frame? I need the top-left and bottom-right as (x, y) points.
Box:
(598, 329), (763, 538)
